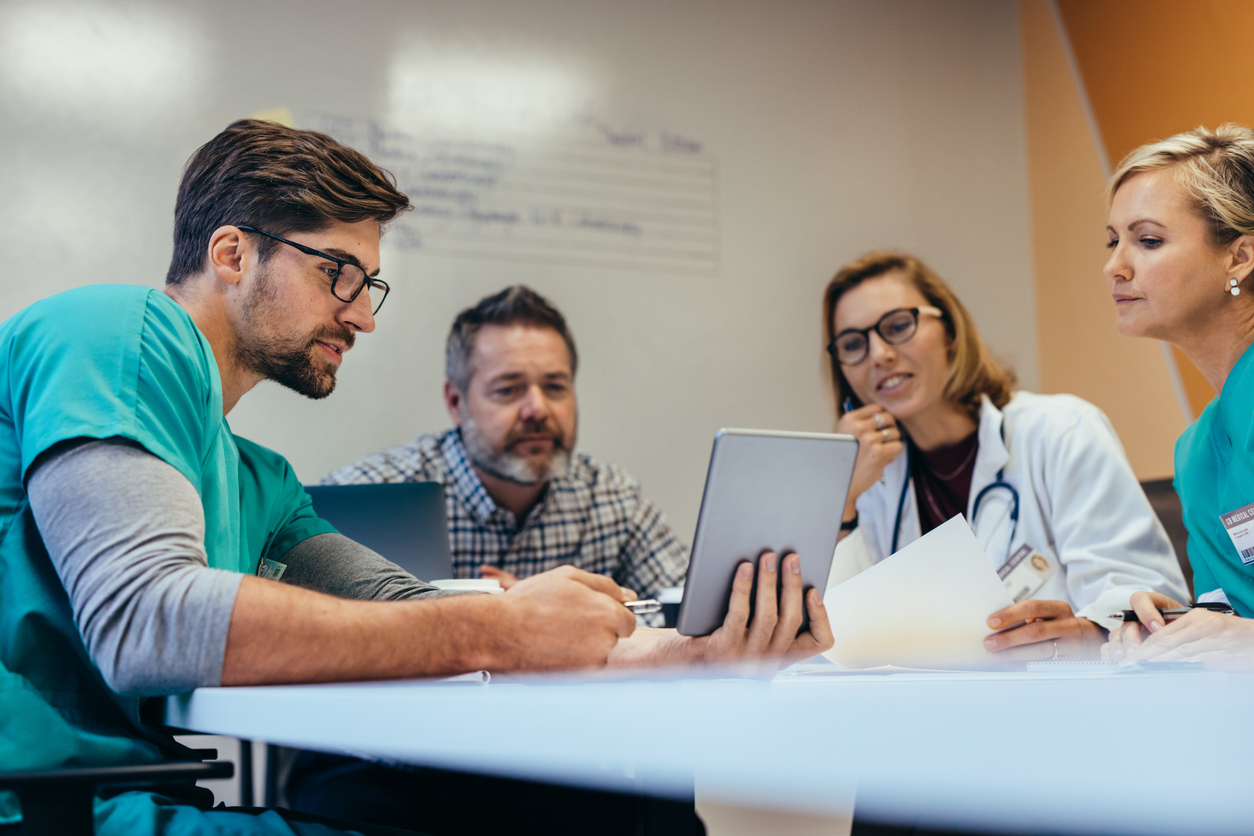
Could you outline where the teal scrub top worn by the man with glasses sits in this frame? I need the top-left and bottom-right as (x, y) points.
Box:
(0, 285), (335, 823)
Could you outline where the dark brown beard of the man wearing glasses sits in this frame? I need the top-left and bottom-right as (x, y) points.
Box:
(234, 264), (355, 400)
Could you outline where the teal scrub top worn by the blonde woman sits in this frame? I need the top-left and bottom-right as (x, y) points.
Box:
(1175, 338), (1254, 618)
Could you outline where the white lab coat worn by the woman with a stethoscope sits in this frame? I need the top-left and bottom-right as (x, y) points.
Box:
(828, 392), (1188, 629)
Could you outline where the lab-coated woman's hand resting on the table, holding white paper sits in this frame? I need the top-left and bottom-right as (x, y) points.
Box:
(984, 600), (1106, 662)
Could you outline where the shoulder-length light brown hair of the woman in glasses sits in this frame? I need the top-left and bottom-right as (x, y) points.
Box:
(823, 249), (1017, 421)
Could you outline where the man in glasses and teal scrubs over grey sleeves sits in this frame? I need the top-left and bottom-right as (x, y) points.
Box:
(0, 120), (830, 833)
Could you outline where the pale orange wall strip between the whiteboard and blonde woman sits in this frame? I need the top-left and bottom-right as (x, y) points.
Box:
(1020, 0), (1185, 479)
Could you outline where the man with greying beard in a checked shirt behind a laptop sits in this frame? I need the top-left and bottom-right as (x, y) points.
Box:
(322, 285), (687, 598)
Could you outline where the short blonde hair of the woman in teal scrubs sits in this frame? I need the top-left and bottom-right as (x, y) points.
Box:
(1106, 122), (1254, 246)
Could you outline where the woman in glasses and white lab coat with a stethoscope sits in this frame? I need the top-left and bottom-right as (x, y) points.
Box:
(824, 252), (1188, 661)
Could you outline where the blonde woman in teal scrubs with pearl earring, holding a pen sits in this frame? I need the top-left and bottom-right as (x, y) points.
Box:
(1104, 124), (1254, 669)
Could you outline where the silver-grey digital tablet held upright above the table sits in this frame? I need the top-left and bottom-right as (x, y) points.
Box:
(677, 430), (858, 635)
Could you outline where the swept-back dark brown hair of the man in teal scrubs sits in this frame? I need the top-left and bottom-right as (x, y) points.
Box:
(166, 119), (413, 285)
